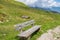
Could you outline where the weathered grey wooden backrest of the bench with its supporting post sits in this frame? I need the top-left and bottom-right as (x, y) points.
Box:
(14, 20), (35, 32)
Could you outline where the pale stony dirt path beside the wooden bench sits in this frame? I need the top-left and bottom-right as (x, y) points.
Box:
(37, 26), (60, 40)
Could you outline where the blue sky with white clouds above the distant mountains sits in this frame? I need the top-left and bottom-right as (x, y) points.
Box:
(16, 0), (60, 8)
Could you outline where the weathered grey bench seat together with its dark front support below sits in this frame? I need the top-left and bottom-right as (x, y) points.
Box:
(18, 25), (40, 40)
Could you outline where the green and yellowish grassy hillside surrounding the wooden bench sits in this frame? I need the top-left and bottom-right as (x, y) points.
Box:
(0, 0), (60, 40)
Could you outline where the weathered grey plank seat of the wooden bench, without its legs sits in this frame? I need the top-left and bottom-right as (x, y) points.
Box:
(18, 25), (40, 38)
